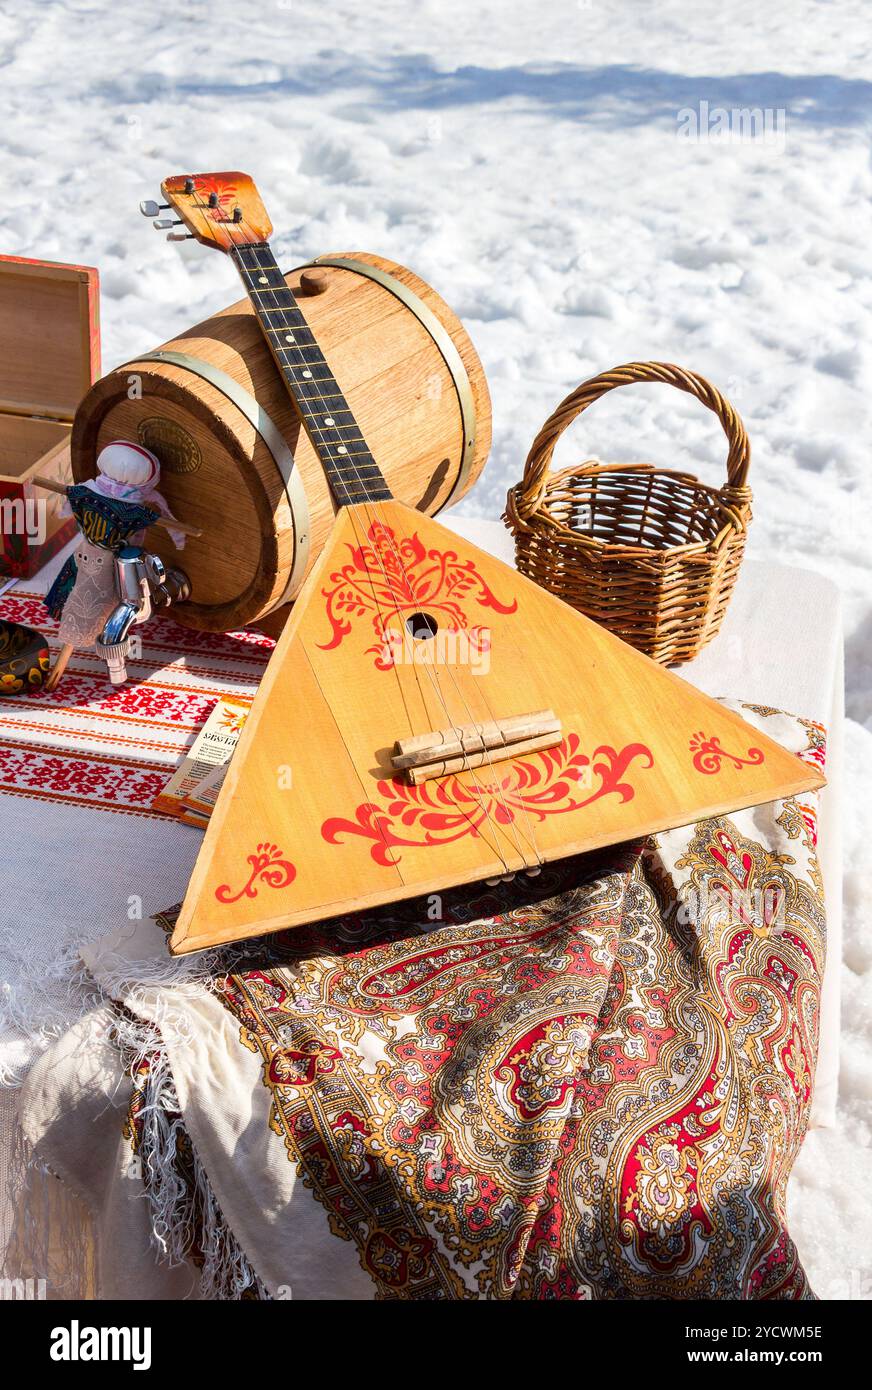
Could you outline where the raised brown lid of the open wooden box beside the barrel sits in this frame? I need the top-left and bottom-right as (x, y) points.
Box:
(0, 256), (100, 421)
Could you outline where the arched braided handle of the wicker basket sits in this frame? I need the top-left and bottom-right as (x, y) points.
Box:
(513, 361), (751, 517)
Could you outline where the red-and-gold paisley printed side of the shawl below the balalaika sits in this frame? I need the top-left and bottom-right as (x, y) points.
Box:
(201, 723), (825, 1300)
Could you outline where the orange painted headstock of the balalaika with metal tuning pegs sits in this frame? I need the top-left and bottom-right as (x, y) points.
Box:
(139, 172), (273, 252)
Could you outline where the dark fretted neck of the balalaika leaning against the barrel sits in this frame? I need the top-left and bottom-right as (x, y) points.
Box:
(231, 242), (391, 506)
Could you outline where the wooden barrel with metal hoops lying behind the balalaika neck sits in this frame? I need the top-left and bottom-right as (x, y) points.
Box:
(72, 252), (491, 632)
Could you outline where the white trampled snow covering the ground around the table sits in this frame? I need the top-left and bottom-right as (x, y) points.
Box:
(0, 0), (872, 1298)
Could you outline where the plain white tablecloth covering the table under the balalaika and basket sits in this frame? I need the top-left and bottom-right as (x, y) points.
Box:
(0, 514), (843, 1250)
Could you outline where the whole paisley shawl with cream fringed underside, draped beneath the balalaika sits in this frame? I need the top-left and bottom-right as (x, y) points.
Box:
(17, 706), (825, 1300)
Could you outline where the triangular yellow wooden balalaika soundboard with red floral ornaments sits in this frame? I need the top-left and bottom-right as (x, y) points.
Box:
(171, 502), (823, 954)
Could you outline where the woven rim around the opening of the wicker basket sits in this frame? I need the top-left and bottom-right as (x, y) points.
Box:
(509, 459), (751, 563)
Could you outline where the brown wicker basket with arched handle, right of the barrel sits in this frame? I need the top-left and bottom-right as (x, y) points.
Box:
(505, 361), (751, 664)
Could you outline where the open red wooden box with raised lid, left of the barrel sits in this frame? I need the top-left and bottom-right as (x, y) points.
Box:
(0, 256), (100, 578)
